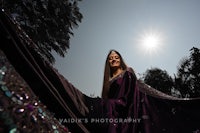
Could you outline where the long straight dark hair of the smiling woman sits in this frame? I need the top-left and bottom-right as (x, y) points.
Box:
(102, 50), (127, 99)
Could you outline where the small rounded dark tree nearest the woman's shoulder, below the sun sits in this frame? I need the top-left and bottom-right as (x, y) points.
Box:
(144, 68), (173, 95)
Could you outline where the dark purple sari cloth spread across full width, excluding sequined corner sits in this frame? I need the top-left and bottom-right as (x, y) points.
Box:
(0, 11), (200, 133)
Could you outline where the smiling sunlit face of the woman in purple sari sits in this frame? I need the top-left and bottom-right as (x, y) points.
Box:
(108, 51), (121, 68)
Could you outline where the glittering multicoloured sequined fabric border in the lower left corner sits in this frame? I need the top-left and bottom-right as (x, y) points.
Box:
(0, 50), (68, 133)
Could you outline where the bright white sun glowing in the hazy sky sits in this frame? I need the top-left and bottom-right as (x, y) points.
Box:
(139, 31), (162, 54)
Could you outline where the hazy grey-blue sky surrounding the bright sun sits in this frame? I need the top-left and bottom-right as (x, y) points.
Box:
(55, 0), (200, 96)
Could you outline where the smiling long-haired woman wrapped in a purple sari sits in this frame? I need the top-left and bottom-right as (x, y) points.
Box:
(102, 50), (139, 132)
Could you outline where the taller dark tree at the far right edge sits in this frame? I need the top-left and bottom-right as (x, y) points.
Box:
(175, 47), (200, 97)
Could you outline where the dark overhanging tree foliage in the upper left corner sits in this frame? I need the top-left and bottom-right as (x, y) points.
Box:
(0, 0), (83, 63)
